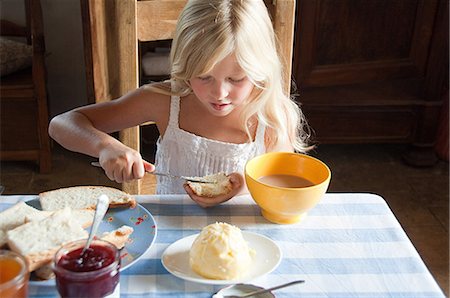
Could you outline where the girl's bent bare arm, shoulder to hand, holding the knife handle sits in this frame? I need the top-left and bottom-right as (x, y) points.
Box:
(49, 89), (168, 183)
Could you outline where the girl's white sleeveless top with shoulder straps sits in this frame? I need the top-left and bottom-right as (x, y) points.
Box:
(155, 96), (266, 194)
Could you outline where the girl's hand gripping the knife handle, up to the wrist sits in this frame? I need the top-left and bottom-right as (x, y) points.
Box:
(99, 144), (155, 183)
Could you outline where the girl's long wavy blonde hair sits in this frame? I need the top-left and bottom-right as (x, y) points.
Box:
(146, 0), (309, 152)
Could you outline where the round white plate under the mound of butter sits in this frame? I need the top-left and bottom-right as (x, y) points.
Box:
(161, 231), (281, 285)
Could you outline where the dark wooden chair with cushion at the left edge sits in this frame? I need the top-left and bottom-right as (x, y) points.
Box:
(0, 0), (51, 173)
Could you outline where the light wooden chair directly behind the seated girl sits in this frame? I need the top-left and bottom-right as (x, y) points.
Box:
(81, 0), (295, 194)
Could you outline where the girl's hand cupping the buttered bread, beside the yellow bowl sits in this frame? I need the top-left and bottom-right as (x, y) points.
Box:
(184, 173), (245, 208)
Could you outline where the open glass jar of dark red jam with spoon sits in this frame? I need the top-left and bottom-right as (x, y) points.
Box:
(53, 240), (120, 298)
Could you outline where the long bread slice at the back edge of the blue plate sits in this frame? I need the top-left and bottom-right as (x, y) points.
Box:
(39, 186), (136, 210)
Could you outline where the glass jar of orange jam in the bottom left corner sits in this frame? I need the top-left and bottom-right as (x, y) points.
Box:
(0, 250), (29, 298)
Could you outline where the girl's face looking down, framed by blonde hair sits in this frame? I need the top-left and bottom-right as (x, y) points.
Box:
(189, 55), (254, 116)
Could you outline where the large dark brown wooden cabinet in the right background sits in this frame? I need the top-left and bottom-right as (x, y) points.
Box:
(293, 0), (448, 165)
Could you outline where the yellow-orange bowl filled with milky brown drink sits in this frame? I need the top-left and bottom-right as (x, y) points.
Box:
(245, 152), (331, 224)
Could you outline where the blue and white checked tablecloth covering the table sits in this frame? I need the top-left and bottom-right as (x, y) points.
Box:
(0, 193), (444, 298)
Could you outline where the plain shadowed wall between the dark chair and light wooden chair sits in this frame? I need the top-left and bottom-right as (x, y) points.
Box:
(0, 0), (87, 116)
